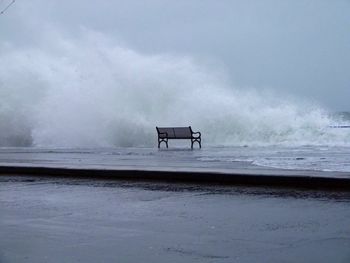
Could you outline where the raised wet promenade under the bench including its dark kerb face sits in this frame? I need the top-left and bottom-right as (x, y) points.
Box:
(0, 148), (350, 189)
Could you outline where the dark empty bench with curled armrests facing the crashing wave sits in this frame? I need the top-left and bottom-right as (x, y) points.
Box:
(156, 126), (202, 149)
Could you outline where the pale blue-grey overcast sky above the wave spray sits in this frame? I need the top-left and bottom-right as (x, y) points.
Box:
(0, 0), (350, 111)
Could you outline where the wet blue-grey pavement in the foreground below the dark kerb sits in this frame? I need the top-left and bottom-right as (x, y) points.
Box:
(0, 176), (350, 263)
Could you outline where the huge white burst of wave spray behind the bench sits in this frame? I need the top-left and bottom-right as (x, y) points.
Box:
(0, 31), (350, 147)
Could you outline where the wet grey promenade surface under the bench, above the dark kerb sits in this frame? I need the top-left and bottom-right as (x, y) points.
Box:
(0, 147), (350, 179)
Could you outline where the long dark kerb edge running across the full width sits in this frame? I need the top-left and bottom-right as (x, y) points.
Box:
(0, 166), (350, 190)
